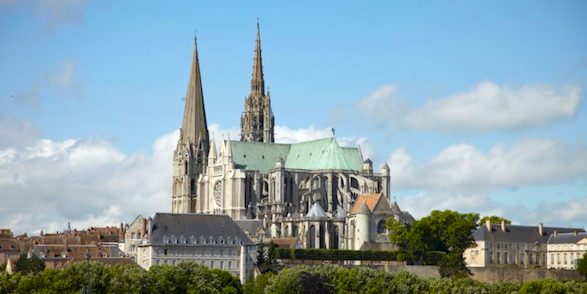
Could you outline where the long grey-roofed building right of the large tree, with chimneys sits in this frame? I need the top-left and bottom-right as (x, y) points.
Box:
(463, 220), (584, 268)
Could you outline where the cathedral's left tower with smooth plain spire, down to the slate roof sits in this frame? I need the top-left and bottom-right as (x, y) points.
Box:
(171, 39), (210, 213)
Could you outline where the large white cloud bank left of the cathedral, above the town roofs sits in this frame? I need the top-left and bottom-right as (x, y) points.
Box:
(0, 131), (179, 233)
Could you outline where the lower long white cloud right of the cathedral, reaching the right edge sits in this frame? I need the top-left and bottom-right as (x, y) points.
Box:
(388, 139), (587, 191)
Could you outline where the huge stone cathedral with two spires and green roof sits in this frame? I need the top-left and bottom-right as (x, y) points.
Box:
(172, 23), (414, 250)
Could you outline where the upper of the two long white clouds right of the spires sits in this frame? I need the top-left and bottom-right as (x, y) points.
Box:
(340, 82), (581, 131)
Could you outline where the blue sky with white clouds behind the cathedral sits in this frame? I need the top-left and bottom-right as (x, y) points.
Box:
(0, 0), (587, 232)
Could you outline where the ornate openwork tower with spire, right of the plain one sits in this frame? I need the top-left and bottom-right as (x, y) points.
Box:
(241, 21), (275, 143)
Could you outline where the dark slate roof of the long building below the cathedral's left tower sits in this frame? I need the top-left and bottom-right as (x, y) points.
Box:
(151, 213), (252, 244)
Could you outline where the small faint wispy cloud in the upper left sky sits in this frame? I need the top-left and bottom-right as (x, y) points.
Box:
(14, 60), (81, 108)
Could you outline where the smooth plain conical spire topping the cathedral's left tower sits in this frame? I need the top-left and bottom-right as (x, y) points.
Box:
(181, 36), (208, 146)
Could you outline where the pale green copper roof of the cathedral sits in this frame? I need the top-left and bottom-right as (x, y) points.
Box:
(230, 138), (363, 173)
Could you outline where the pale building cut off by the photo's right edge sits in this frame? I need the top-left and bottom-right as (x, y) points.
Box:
(547, 231), (587, 270)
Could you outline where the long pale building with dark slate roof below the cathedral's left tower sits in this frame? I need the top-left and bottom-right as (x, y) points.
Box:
(136, 213), (257, 283)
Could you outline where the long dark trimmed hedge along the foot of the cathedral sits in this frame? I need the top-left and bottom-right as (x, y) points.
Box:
(275, 248), (397, 260)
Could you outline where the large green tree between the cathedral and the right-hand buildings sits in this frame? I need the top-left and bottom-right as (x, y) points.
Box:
(386, 210), (479, 277)
